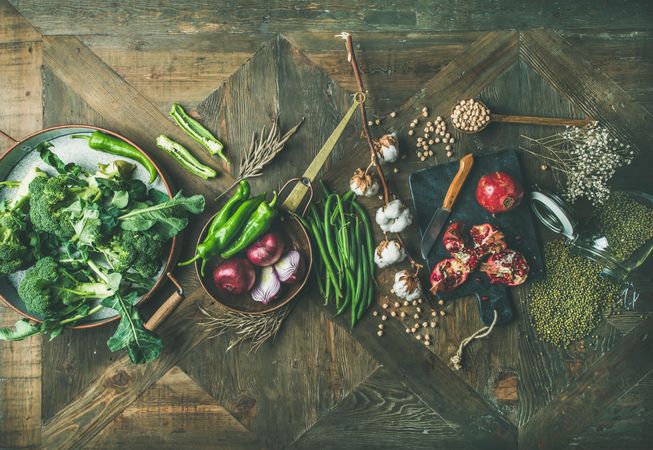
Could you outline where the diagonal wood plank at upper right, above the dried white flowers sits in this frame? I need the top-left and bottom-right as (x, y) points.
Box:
(520, 30), (653, 190)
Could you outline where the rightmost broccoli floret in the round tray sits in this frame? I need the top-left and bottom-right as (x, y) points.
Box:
(98, 230), (164, 278)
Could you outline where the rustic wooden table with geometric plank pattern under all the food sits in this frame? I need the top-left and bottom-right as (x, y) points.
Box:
(0, 0), (653, 449)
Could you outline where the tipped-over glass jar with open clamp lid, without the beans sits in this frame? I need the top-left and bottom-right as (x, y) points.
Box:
(529, 188), (653, 309)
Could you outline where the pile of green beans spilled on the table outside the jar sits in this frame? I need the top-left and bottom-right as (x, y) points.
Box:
(528, 240), (620, 347)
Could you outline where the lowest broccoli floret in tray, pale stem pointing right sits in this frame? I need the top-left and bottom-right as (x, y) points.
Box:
(18, 256), (115, 314)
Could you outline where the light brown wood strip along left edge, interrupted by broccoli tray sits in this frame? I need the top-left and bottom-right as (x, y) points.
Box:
(0, 1), (42, 448)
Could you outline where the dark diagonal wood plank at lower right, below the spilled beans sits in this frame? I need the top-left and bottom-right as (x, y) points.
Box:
(519, 318), (653, 449)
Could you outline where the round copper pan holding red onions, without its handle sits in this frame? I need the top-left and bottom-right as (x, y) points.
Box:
(195, 213), (313, 314)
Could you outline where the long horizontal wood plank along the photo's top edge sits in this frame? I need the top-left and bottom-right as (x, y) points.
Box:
(11, 0), (651, 35)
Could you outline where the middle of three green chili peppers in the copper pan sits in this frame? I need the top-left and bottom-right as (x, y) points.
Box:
(179, 194), (265, 270)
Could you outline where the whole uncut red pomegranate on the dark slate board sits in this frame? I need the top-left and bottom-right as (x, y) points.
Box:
(476, 172), (524, 214)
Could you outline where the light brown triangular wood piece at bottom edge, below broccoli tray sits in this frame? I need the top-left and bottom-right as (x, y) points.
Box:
(84, 367), (262, 450)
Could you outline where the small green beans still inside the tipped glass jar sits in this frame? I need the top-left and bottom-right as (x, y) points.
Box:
(590, 192), (653, 261)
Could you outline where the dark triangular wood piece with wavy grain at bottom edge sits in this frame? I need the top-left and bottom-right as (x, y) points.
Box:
(289, 368), (469, 450)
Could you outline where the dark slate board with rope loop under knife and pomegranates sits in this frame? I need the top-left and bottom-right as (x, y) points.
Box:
(409, 150), (544, 325)
